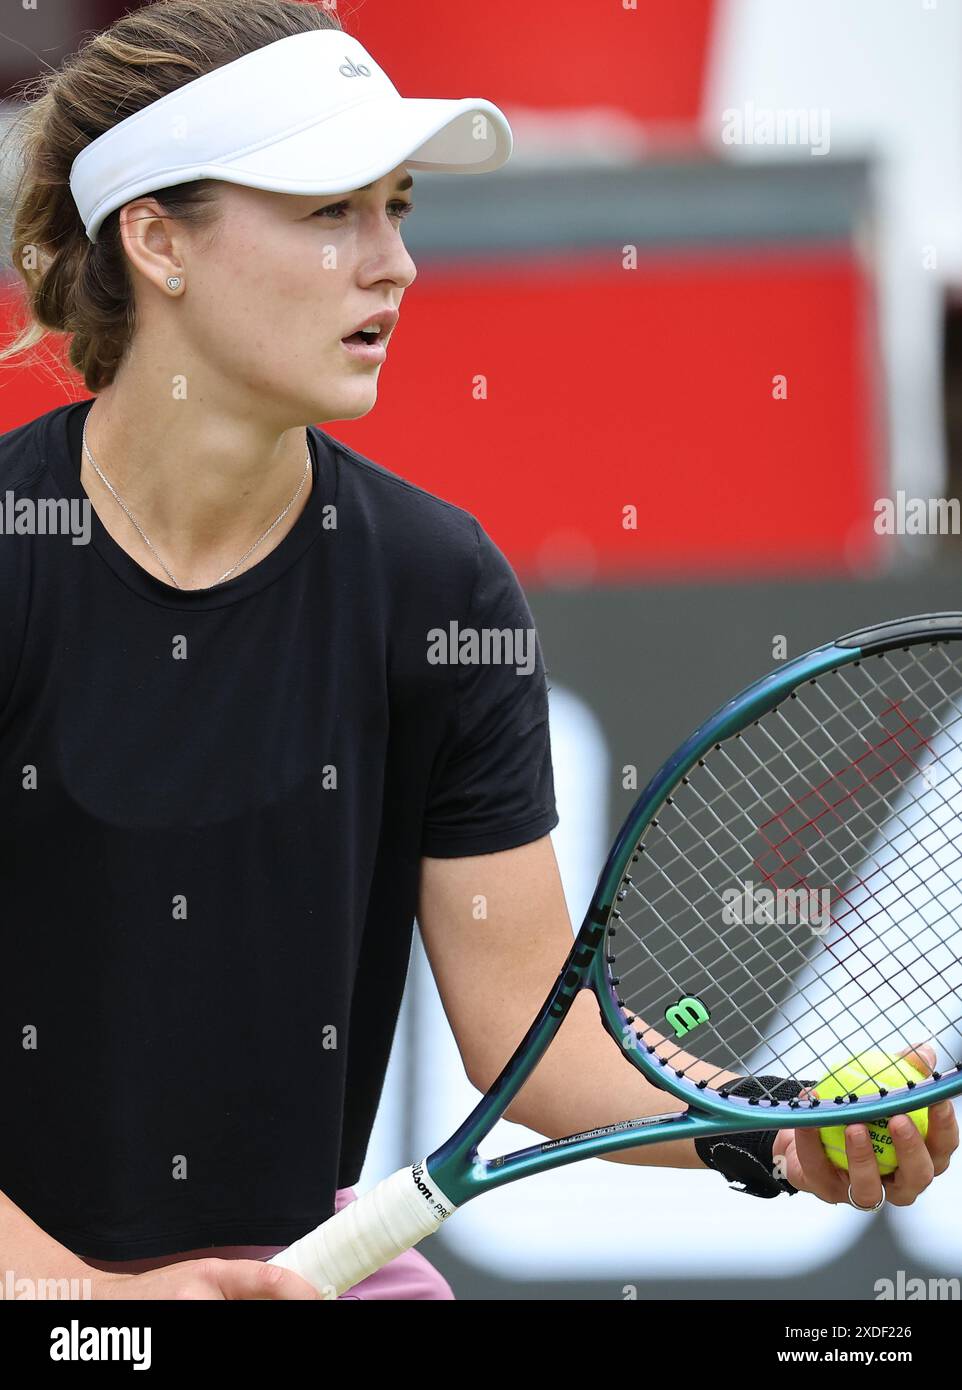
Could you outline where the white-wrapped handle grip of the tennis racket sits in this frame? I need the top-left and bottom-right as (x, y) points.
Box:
(267, 1159), (455, 1298)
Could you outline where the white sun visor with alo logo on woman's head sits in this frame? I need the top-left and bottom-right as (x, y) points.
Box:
(70, 29), (513, 242)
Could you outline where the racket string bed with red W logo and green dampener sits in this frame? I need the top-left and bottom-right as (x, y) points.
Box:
(609, 642), (962, 1106)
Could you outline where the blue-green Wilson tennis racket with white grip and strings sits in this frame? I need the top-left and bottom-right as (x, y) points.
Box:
(271, 613), (962, 1297)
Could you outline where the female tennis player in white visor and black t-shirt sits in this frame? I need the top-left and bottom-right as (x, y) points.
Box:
(0, 0), (958, 1300)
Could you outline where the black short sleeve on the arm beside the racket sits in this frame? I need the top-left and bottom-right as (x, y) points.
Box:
(421, 523), (557, 859)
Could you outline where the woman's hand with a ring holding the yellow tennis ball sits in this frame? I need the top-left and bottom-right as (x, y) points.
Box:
(774, 1045), (959, 1209)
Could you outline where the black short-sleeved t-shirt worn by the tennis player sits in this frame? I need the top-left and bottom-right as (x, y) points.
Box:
(0, 400), (557, 1259)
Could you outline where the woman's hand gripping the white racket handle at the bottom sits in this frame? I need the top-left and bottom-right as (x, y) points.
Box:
(92, 1259), (321, 1300)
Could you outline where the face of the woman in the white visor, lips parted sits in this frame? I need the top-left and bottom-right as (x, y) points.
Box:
(170, 164), (417, 424)
